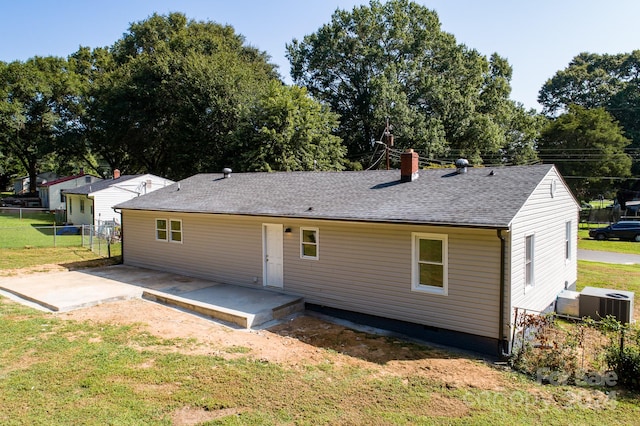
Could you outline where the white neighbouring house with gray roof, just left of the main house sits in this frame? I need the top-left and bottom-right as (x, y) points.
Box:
(64, 169), (174, 227)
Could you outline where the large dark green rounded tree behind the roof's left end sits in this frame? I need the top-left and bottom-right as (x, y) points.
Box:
(75, 13), (278, 179)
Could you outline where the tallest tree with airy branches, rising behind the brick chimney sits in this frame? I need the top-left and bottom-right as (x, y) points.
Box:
(287, 0), (514, 163)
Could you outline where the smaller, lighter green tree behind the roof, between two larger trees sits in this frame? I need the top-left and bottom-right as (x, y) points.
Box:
(234, 82), (345, 172)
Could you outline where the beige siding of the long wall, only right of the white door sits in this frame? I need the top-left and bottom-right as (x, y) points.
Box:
(285, 221), (500, 338)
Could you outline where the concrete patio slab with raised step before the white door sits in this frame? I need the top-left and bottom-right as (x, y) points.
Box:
(0, 265), (304, 328)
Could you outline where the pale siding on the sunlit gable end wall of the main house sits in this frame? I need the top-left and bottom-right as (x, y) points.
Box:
(511, 169), (578, 310)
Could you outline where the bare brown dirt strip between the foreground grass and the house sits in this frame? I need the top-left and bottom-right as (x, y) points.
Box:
(56, 299), (507, 390)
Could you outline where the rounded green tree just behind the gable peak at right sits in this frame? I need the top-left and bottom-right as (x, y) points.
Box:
(538, 105), (631, 200)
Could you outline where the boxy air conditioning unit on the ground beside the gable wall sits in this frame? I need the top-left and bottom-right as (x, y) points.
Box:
(580, 287), (633, 324)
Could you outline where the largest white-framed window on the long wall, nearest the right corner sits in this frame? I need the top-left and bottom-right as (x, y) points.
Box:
(411, 233), (449, 295)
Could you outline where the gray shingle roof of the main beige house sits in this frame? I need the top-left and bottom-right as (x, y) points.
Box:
(116, 165), (553, 227)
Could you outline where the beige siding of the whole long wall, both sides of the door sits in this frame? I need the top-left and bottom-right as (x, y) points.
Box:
(123, 210), (500, 338)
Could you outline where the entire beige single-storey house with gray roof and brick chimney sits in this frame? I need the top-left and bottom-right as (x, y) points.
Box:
(117, 152), (579, 355)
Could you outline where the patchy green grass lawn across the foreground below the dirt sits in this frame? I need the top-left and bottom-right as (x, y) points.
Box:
(0, 292), (640, 425)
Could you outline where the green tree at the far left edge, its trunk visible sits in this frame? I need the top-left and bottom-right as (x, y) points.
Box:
(0, 57), (82, 192)
